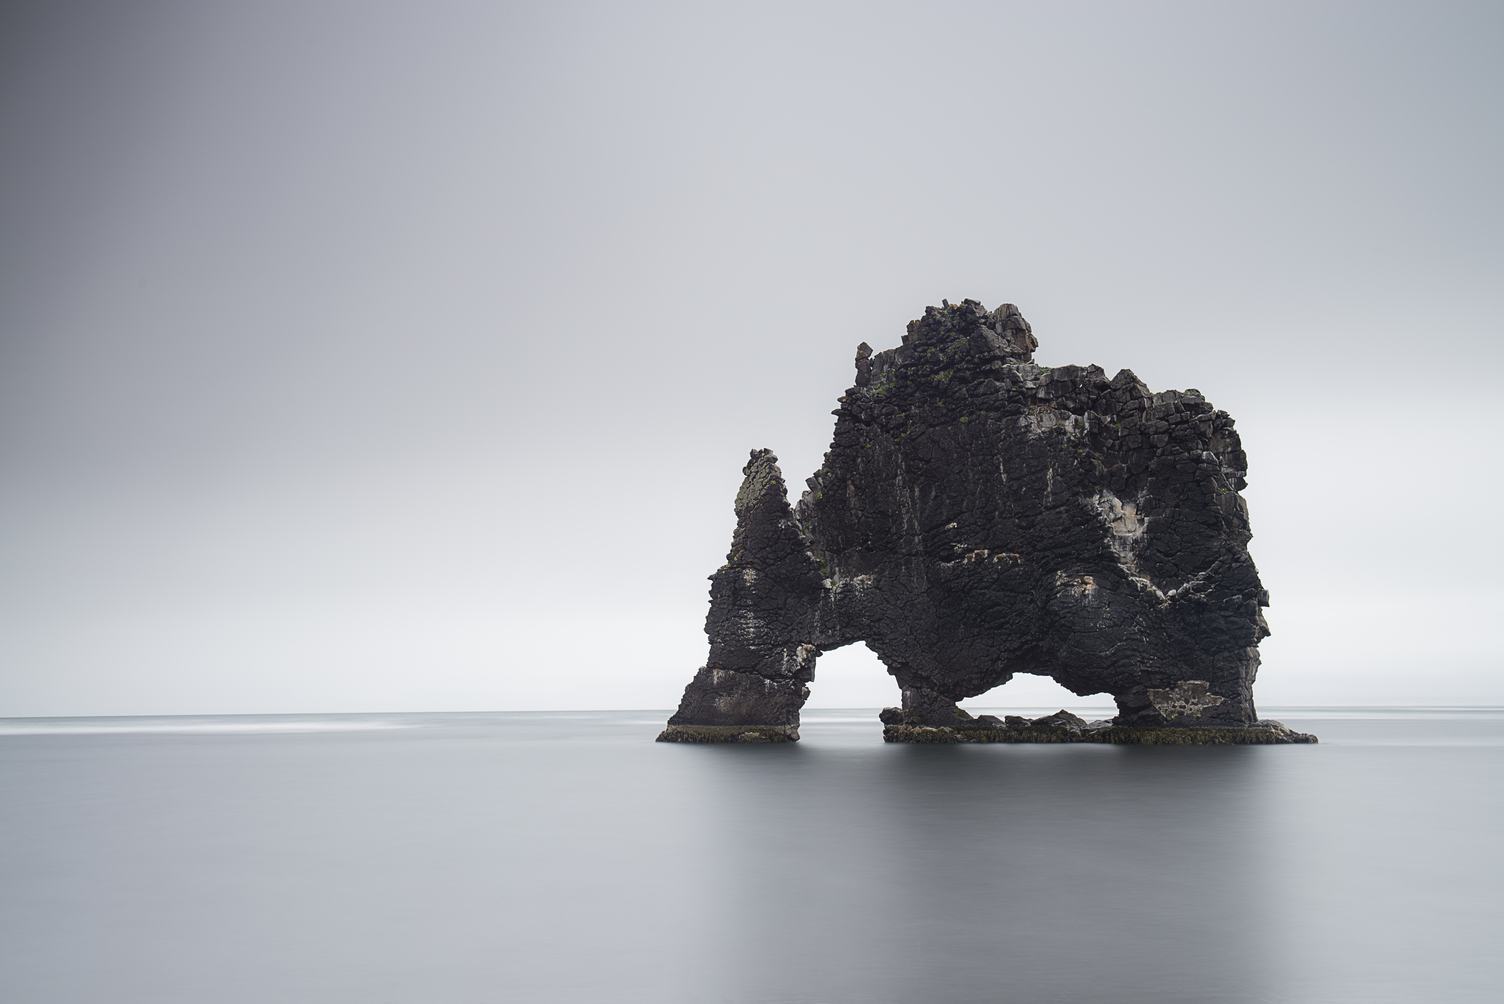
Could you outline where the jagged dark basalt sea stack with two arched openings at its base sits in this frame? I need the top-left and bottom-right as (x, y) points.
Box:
(659, 301), (1313, 742)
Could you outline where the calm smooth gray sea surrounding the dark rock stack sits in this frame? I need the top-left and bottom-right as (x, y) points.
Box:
(0, 709), (1504, 1004)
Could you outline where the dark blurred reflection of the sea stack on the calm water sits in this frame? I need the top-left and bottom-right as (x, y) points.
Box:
(699, 747), (1280, 1001)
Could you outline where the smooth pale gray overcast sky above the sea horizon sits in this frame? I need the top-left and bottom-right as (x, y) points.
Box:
(0, 0), (1504, 715)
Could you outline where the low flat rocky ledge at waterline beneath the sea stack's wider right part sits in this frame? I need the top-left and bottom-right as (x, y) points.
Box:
(883, 711), (1316, 745)
